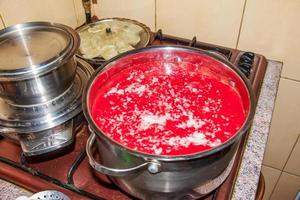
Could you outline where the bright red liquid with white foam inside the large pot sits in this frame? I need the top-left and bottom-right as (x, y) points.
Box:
(90, 50), (247, 156)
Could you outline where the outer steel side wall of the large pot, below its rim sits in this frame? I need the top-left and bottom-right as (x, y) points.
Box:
(87, 130), (239, 199)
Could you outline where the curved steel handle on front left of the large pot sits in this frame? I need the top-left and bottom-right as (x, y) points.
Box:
(86, 133), (161, 176)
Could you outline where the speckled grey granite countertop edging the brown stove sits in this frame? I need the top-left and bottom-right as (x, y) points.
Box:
(0, 61), (282, 200)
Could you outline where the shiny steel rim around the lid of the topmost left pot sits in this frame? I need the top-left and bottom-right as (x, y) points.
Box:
(0, 21), (80, 81)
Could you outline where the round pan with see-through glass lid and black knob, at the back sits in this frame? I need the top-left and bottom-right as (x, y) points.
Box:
(77, 18), (151, 65)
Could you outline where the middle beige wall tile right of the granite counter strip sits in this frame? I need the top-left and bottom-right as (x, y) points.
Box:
(264, 79), (300, 169)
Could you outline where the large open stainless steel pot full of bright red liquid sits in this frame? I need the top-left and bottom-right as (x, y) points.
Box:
(83, 46), (254, 199)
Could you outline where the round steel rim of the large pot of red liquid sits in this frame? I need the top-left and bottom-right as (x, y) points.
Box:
(82, 45), (255, 162)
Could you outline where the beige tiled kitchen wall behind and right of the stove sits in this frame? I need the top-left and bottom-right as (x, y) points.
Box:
(0, 0), (300, 200)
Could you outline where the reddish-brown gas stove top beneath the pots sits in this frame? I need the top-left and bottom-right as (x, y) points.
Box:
(0, 30), (267, 200)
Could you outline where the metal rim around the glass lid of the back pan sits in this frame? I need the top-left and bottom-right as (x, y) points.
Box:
(76, 18), (151, 65)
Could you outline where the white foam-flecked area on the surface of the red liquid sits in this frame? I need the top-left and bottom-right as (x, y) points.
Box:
(92, 56), (247, 155)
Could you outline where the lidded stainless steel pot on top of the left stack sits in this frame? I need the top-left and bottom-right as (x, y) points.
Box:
(0, 22), (80, 105)
